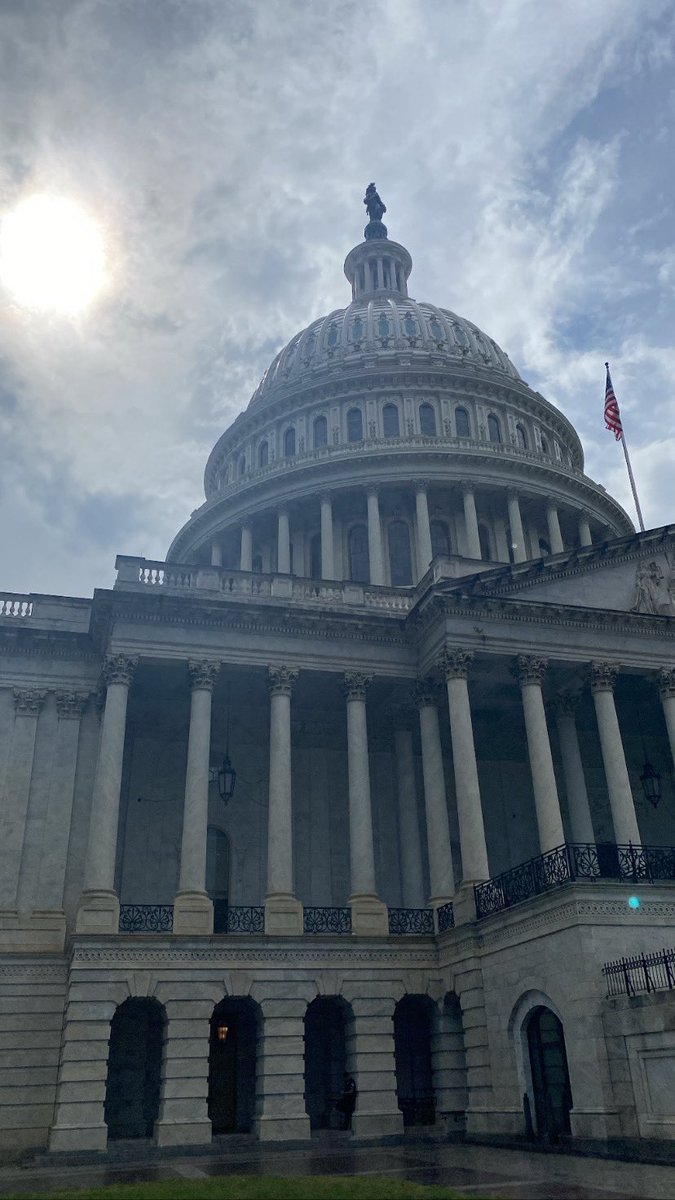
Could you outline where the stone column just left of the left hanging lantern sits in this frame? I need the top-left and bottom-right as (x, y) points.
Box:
(173, 660), (220, 935)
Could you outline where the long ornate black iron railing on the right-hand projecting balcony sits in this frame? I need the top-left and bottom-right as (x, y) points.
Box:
(474, 842), (675, 919)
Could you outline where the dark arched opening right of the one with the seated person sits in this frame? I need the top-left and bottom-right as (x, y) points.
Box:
(394, 996), (436, 1126)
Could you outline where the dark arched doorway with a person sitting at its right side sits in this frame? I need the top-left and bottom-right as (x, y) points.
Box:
(305, 996), (351, 1129)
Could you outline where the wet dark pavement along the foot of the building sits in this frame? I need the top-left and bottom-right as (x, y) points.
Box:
(0, 1139), (675, 1200)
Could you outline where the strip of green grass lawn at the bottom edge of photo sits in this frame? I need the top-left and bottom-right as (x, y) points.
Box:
(14, 1175), (477, 1200)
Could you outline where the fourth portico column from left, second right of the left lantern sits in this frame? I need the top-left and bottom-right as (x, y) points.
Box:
(345, 671), (389, 936)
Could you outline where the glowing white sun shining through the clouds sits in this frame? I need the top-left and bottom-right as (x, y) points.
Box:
(0, 194), (104, 316)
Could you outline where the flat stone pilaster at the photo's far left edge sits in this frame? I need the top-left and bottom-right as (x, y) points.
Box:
(0, 688), (47, 908)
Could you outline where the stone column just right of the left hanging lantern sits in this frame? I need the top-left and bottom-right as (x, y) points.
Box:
(265, 666), (303, 934)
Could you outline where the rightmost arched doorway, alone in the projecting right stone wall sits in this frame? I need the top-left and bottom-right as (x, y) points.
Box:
(527, 1006), (572, 1141)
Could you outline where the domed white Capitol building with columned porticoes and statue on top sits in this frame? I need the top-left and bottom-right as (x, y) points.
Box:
(0, 192), (675, 1154)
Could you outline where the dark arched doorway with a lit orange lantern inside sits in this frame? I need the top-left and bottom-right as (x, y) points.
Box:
(208, 996), (258, 1134)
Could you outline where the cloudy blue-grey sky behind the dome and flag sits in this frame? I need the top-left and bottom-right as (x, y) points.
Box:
(0, 0), (675, 595)
